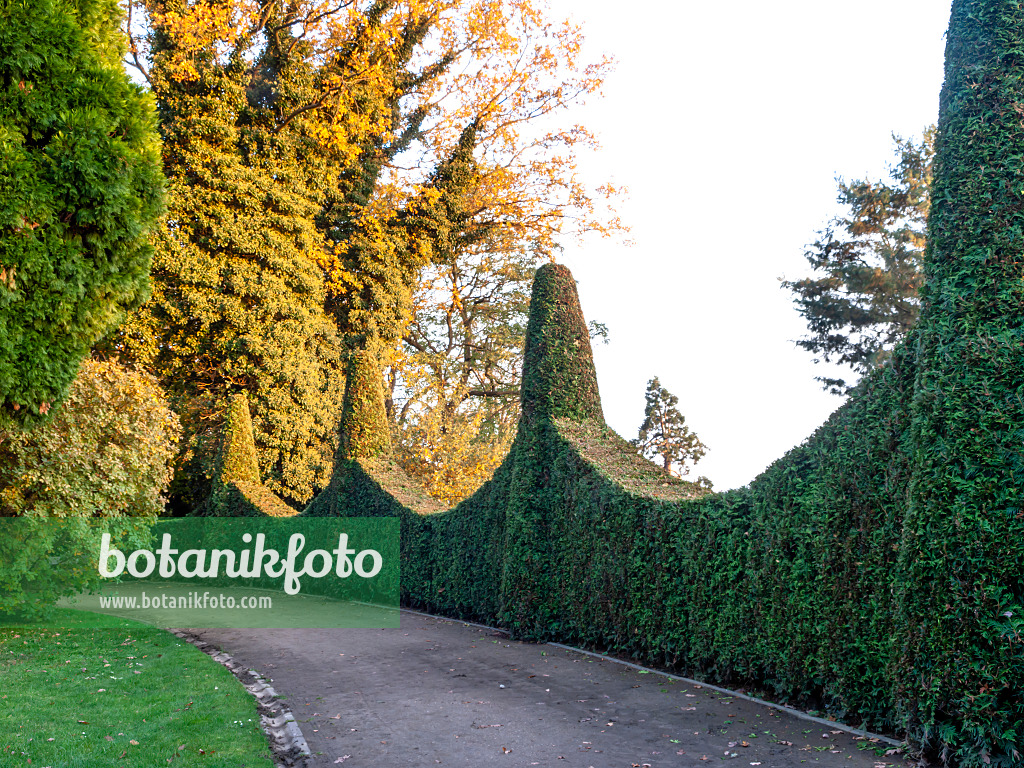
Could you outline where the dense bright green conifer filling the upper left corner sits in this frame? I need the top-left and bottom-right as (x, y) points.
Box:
(0, 0), (164, 424)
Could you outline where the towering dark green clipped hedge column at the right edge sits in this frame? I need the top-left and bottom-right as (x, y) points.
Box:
(897, 0), (1024, 766)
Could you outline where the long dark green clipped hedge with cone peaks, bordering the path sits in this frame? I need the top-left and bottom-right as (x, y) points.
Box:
(307, 0), (1024, 767)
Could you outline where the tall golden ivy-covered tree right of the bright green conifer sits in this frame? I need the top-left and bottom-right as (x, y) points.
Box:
(114, 0), (354, 506)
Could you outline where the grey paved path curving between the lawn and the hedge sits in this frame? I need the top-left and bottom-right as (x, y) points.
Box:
(197, 612), (903, 768)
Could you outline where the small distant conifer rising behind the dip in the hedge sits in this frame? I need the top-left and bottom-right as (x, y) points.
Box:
(632, 376), (710, 487)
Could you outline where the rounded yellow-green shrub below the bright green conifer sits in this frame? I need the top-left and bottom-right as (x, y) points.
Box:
(0, 359), (179, 613)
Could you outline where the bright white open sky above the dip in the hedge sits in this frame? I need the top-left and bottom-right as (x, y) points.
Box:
(551, 0), (950, 490)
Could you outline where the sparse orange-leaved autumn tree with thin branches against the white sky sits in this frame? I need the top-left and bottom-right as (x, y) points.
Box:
(319, 0), (620, 354)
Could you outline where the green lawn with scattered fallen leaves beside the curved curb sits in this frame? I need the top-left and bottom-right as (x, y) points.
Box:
(0, 610), (272, 768)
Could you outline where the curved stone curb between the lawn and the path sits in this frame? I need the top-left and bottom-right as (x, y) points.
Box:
(171, 630), (311, 768)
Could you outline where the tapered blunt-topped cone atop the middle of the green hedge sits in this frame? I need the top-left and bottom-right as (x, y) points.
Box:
(521, 264), (604, 424)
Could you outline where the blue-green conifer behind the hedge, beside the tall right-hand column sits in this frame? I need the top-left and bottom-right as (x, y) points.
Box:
(782, 128), (935, 394)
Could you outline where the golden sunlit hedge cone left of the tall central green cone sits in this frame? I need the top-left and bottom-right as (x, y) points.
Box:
(338, 349), (391, 460)
